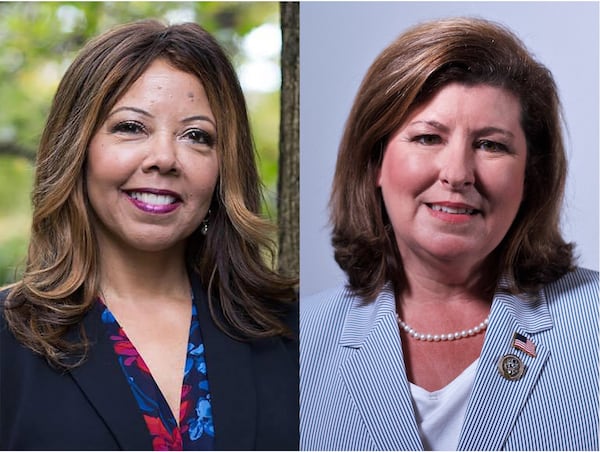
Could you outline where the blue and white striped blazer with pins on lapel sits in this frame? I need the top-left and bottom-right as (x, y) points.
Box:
(300, 269), (599, 450)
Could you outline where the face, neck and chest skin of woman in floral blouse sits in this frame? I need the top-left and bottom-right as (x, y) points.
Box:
(86, 60), (219, 420)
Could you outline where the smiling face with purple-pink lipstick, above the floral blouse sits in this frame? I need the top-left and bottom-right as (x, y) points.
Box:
(86, 59), (219, 251)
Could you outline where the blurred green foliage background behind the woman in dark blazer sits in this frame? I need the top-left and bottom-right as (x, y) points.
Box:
(0, 2), (281, 286)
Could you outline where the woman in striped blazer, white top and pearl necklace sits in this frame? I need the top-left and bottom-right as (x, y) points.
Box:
(300, 17), (599, 450)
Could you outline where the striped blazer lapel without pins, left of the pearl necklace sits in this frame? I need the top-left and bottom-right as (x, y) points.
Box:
(340, 288), (423, 450)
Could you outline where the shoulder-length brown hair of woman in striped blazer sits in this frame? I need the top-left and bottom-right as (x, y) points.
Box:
(330, 18), (574, 300)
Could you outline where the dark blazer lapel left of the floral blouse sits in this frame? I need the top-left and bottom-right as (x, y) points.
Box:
(70, 304), (152, 450)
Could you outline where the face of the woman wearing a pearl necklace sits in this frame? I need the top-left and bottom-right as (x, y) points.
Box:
(377, 84), (527, 268)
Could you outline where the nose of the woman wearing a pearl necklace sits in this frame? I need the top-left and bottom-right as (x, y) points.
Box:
(439, 142), (475, 190)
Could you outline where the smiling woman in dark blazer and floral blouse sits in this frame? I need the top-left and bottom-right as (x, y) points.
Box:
(0, 21), (298, 450)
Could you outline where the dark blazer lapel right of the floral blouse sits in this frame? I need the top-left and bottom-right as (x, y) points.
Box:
(190, 275), (257, 450)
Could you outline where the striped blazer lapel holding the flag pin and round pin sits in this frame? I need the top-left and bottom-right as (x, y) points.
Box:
(458, 293), (552, 450)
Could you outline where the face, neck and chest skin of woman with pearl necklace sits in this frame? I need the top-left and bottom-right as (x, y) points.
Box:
(377, 84), (527, 391)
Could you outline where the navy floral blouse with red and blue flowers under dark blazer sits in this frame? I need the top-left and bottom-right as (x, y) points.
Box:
(102, 303), (215, 450)
